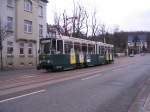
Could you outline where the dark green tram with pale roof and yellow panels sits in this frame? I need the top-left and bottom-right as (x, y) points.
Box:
(37, 36), (114, 71)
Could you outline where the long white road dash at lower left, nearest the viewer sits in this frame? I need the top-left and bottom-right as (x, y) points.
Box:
(0, 89), (46, 103)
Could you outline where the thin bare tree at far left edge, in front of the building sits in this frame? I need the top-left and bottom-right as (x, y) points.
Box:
(0, 19), (8, 70)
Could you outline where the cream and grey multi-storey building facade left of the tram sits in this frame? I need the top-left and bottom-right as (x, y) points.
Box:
(0, 0), (47, 68)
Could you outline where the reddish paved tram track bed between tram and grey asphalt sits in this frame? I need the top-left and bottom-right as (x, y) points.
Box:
(0, 54), (148, 94)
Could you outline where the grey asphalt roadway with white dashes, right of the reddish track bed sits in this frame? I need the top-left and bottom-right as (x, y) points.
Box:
(0, 55), (150, 112)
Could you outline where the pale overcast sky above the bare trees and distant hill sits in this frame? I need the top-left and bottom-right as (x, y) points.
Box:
(47, 0), (150, 31)
